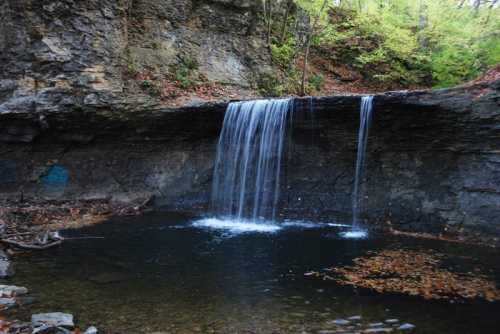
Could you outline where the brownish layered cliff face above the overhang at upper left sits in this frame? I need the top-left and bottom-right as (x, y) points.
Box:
(0, 0), (269, 112)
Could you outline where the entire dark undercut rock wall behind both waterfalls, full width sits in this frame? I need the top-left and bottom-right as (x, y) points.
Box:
(0, 81), (500, 243)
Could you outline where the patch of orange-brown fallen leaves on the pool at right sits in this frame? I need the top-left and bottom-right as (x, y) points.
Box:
(305, 250), (500, 301)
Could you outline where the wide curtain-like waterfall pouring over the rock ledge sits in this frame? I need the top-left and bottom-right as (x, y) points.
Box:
(212, 99), (292, 220)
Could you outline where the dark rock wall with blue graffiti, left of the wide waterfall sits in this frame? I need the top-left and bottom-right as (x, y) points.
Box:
(0, 105), (225, 208)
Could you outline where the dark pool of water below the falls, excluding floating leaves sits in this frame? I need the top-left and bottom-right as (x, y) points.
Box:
(3, 212), (500, 334)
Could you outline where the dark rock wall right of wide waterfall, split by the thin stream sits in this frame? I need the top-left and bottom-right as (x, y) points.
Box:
(284, 82), (500, 236)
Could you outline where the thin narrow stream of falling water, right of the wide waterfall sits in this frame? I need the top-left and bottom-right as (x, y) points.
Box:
(352, 96), (373, 229)
